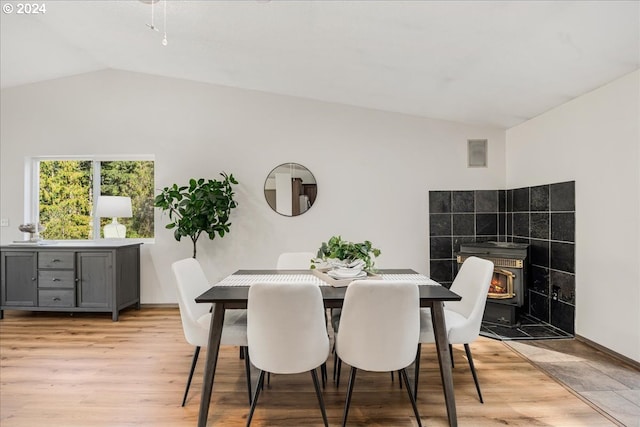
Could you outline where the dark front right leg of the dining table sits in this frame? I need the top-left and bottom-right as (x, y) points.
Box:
(431, 301), (458, 427)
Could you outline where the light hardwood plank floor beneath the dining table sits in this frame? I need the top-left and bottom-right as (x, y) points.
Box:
(0, 307), (616, 427)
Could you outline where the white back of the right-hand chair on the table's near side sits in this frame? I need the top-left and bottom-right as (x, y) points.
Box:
(336, 280), (420, 372)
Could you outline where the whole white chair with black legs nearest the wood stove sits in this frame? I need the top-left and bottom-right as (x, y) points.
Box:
(414, 257), (493, 403)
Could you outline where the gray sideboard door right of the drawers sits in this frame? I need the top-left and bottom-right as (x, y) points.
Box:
(76, 252), (114, 308)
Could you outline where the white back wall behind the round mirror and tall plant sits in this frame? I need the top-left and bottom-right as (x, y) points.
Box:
(0, 71), (505, 303)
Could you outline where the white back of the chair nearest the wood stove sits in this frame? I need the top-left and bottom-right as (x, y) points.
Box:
(445, 257), (493, 343)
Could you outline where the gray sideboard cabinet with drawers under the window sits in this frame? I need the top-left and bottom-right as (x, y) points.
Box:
(0, 240), (141, 321)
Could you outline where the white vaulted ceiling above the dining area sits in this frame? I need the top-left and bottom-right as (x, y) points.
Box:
(0, 0), (640, 128)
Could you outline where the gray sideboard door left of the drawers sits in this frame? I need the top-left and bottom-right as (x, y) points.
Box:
(0, 252), (38, 307)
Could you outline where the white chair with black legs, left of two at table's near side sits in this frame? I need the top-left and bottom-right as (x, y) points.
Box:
(247, 283), (329, 427)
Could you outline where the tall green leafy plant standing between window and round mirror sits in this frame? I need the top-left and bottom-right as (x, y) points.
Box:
(154, 172), (238, 258)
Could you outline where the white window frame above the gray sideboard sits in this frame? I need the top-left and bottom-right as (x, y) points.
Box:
(24, 154), (156, 243)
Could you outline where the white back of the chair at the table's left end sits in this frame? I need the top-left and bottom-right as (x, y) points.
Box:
(171, 258), (211, 346)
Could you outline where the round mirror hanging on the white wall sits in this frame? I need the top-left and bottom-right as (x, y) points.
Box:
(264, 163), (318, 216)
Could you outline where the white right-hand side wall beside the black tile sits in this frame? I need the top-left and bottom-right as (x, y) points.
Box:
(506, 71), (640, 361)
